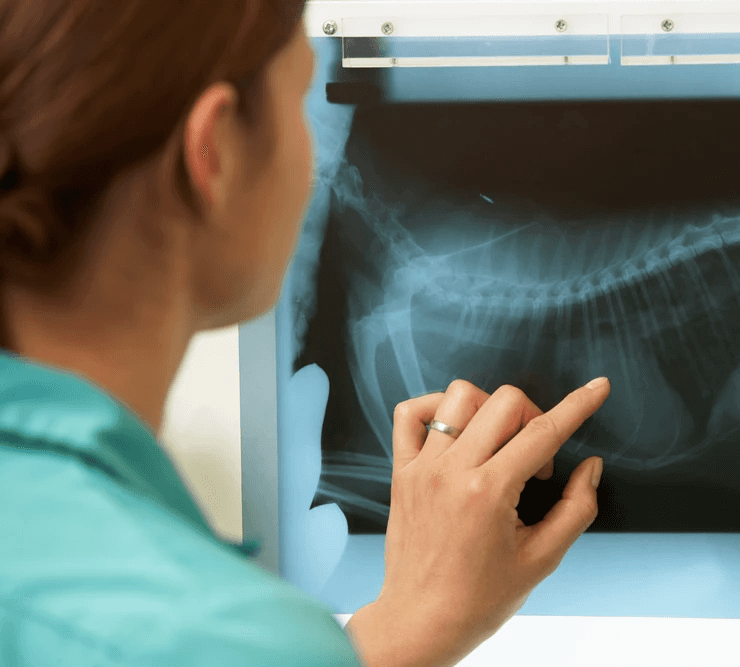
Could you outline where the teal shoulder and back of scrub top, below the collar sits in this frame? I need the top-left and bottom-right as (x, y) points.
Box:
(0, 446), (359, 667)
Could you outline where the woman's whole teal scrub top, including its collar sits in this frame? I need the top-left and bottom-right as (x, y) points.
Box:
(0, 350), (360, 667)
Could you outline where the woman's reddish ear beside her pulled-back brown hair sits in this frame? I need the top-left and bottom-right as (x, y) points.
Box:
(184, 82), (238, 206)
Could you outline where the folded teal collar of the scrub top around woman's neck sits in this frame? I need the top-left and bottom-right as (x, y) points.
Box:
(0, 349), (260, 557)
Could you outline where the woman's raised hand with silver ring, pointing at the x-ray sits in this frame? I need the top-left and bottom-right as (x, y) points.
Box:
(347, 380), (609, 667)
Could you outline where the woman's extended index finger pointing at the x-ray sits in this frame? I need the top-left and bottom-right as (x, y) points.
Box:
(492, 378), (611, 486)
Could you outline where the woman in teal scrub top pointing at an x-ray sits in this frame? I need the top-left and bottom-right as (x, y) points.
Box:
(0, 0), (608, 667)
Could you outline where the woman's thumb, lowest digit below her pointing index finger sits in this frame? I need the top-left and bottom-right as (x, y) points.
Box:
(527, 456), (601, 574)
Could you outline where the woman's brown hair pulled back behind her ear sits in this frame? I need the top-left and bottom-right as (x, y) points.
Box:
(0, 0), (305, 350)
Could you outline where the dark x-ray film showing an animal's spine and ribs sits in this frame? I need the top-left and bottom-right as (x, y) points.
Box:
(294, 103), (740, 533)
